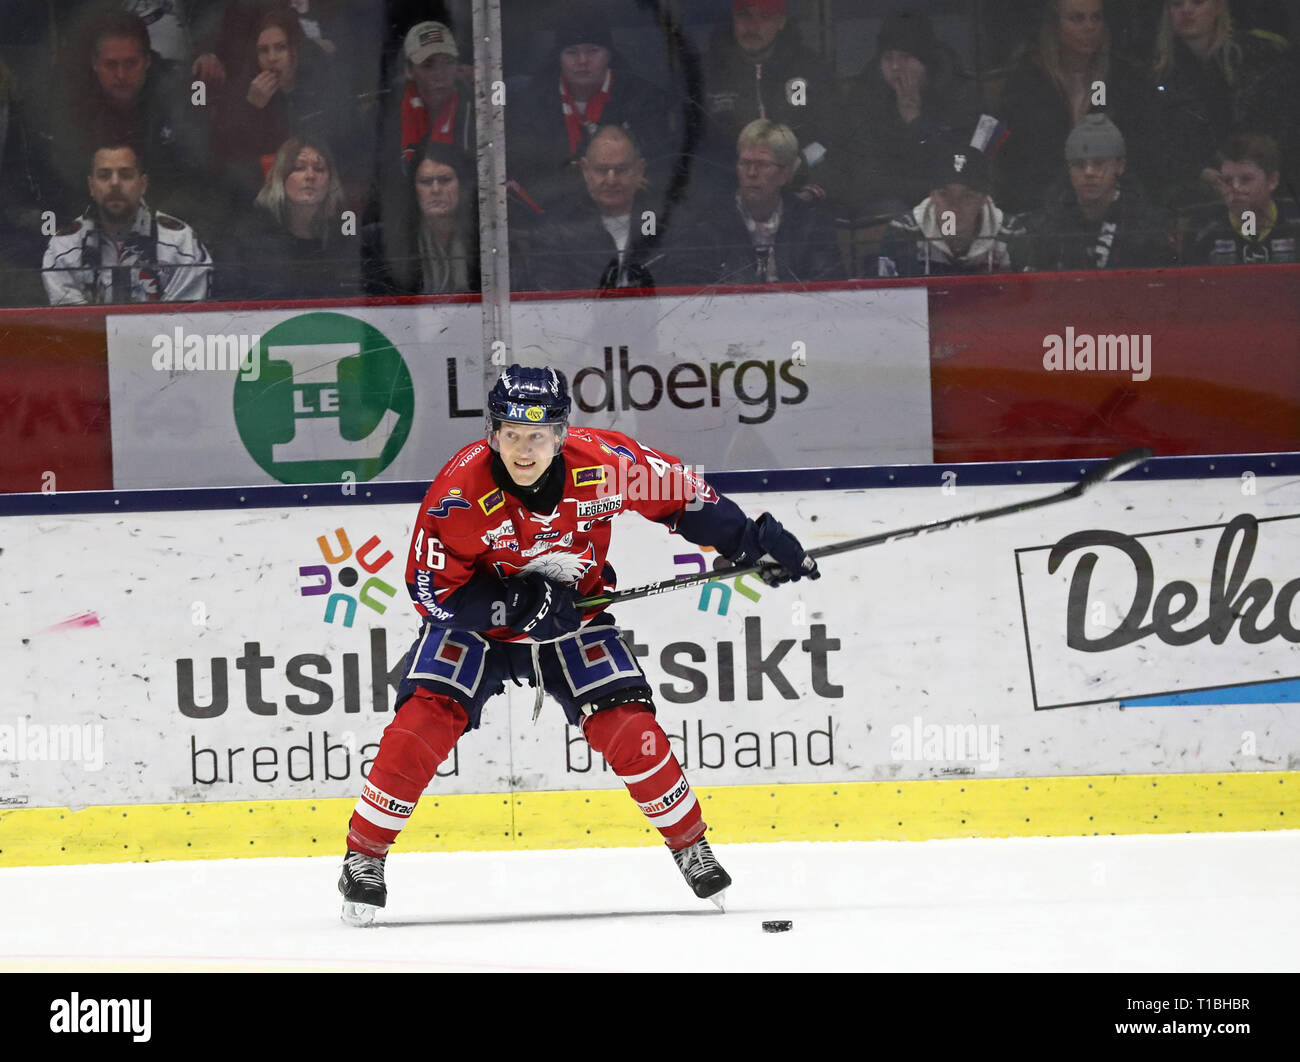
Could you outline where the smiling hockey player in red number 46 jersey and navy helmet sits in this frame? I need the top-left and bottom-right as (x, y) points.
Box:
(338, 365), (820, 926)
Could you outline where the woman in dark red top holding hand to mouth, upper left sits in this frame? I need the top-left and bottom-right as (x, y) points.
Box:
(213, 10), (345, 201)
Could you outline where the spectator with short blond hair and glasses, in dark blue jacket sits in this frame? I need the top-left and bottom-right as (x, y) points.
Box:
(673, 118), (844, 283)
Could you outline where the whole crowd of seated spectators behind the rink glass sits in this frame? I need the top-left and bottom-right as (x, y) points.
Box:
(0, 0), (1300, 305)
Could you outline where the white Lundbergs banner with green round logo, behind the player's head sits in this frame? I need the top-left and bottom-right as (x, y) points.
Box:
(105, 289), (932, 489)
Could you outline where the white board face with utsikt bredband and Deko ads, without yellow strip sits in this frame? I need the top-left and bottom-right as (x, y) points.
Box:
(0, 476), (1300, 806)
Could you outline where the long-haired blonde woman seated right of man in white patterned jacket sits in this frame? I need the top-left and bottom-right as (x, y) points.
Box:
(218, 136), (360, 299)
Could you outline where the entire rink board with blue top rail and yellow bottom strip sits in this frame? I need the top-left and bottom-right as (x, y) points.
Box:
(0, 455), (1300, 863)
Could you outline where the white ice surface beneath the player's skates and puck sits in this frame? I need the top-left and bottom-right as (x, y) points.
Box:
(0, 831), (1300, 972)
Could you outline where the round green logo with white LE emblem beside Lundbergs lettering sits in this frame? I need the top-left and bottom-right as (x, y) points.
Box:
(234, 313), (415, 484)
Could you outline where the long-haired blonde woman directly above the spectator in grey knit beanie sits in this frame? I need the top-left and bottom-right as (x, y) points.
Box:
(997, 0), (1153, 211)
